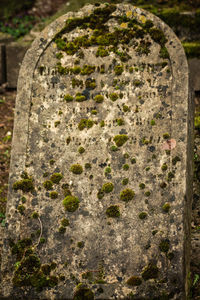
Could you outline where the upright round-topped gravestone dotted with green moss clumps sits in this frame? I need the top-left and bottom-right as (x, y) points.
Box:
(2, 4), (193, 299)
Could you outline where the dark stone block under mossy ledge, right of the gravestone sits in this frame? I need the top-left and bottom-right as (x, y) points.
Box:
(188, 58), (200, 91)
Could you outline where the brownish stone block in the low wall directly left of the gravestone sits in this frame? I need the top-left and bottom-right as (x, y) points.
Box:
(6, 45), (28, 88)
